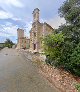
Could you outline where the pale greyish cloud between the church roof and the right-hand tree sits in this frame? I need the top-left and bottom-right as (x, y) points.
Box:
(47, 16), (66, 29)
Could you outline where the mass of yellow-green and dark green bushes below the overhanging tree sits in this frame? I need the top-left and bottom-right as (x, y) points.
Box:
(44, 33), (80, 76)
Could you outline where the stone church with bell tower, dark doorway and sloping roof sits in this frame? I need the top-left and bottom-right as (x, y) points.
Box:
(30, 8), (54, 52)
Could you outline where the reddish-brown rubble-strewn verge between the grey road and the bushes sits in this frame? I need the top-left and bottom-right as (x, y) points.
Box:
(33, 56), (78, 92)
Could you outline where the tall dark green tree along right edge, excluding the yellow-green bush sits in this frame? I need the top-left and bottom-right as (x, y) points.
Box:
(58, 0), (80, 76)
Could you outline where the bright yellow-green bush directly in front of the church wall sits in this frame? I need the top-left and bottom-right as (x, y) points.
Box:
(44, 33), (64, 65)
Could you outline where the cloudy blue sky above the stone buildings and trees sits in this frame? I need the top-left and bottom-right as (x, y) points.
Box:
(0, 0), (65, 43)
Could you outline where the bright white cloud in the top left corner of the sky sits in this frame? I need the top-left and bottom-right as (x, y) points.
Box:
(0, 0), (24, 8)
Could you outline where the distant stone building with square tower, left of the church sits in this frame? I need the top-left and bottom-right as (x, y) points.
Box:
(17, 28), (30, 49)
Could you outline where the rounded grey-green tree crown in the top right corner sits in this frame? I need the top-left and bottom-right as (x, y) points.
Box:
(59, 0), (80, 25)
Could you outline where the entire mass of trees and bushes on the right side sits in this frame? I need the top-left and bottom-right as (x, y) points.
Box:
(44, 0), (80, 76)
